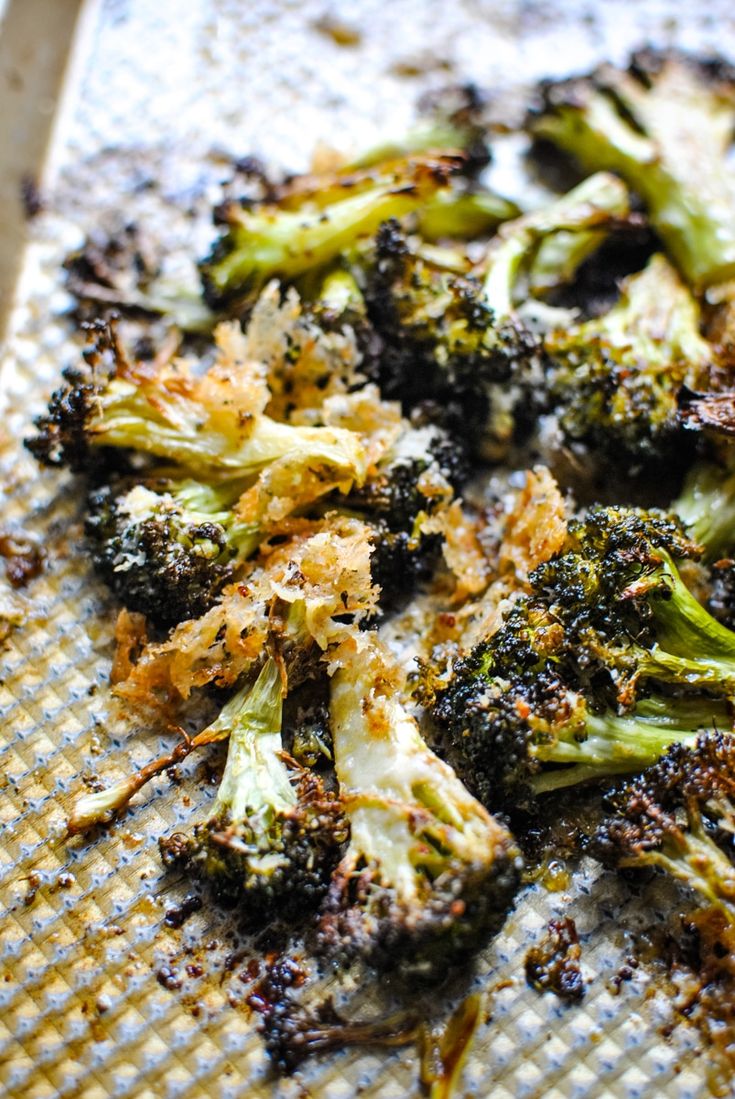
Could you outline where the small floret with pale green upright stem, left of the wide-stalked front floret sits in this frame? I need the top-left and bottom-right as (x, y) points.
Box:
(162, 657), (347, 912)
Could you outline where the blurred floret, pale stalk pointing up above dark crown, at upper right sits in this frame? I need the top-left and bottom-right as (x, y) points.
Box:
(544, 255), (714, 471)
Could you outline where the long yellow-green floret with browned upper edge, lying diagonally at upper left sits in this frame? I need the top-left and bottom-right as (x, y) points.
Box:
(201, 154), (463, 309)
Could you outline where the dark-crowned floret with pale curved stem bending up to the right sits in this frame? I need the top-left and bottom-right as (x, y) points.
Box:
(366, 175), (627, 459)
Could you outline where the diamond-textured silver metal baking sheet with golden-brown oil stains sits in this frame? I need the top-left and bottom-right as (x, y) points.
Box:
(0, 0), (735, 1099)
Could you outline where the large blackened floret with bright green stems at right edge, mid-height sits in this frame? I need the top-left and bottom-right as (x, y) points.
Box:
(435, 508), (735, 806)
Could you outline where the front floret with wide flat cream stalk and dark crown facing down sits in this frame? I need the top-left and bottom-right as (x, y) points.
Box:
(319, 636), (520, 976)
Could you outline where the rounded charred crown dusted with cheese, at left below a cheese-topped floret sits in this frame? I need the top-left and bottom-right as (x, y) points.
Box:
(86, 480), (258, 625)
